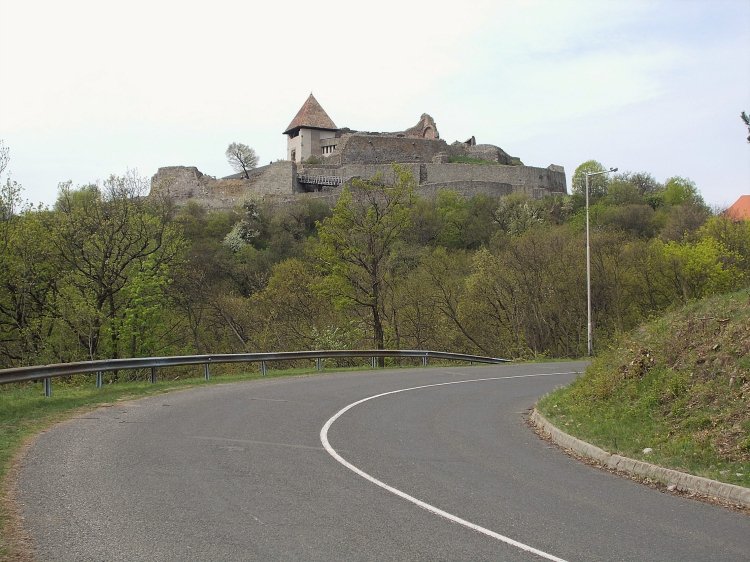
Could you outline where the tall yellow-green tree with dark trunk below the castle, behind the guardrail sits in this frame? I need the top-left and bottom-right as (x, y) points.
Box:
(316, 164), (414, 349)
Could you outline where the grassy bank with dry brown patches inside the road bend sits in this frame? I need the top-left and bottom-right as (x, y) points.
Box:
(537, 290), (750, 487)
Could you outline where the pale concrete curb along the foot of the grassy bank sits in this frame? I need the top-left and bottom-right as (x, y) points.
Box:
(531, 408), (750, 507)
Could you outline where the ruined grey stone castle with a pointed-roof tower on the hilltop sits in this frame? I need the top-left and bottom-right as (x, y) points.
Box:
(151, 94), (566, 209)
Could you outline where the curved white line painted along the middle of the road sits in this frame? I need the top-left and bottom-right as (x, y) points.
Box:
(320, 372), (576, 562)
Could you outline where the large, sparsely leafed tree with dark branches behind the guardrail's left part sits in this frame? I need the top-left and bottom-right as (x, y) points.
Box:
(51, 172), (183, 359)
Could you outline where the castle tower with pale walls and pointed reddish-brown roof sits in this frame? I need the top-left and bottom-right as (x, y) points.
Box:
(284, 94), (338, 162)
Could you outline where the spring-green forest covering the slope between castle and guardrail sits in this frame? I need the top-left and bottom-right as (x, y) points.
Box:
(0, 151), (750, 367)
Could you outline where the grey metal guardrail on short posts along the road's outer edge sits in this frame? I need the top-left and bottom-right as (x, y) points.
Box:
(0, 349), (510, 396)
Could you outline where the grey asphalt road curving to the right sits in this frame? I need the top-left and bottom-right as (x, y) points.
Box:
(18, 363), (750, 562)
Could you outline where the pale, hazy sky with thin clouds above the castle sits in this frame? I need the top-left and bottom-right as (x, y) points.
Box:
(0, 0), (750, 209)
